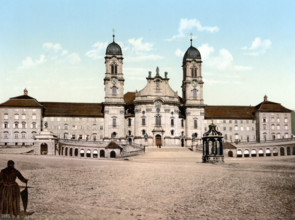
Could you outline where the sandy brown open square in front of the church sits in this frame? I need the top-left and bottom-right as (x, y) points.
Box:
(0, 148), (295, 220)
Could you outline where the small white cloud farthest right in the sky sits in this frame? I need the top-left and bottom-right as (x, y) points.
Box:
(242, 37), (272, 56)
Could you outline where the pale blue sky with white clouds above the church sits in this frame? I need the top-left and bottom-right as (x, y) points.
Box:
(0, 0), (295, 110)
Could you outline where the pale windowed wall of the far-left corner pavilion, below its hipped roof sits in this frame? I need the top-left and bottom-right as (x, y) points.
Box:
(0, 108), (42, 146)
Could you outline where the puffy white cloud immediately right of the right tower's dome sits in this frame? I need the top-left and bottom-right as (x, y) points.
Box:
(207, 49), (252, 71)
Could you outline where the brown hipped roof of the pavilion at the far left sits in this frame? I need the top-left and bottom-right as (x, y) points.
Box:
(0, 95), (43, 108)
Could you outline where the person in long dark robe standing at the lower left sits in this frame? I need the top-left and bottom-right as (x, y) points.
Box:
(0, 160), (28, 216)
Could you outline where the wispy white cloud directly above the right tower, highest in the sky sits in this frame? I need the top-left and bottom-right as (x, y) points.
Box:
(167, 18), (219, 41)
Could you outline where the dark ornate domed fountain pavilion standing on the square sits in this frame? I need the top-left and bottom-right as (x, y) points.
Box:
(202, 122), (224, 163)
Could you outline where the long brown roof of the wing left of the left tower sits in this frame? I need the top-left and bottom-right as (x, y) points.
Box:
(41, 102), (103, 117)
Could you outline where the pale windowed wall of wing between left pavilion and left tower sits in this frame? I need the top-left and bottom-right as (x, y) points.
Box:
(43, 117), (104, 141)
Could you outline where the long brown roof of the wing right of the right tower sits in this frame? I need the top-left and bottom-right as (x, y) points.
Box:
(205, 106), (256, 120)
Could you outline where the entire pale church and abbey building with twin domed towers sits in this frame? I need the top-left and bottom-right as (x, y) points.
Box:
(0, 36), (292, 147)
